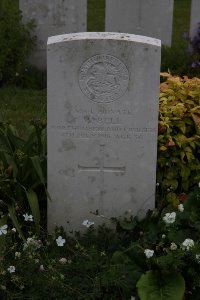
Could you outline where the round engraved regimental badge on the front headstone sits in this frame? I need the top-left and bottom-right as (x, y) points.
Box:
(79, 55), (129, 103)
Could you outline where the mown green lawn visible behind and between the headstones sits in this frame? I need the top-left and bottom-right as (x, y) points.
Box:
(0, 0), (194, 127)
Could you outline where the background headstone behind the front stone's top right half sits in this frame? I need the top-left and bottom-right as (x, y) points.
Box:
(105, 0), (174, 46)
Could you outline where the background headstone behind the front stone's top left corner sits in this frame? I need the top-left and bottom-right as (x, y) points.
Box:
(19, 0), (87, 71)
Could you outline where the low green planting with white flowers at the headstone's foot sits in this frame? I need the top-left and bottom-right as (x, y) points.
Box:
(0, 187), (200, 300)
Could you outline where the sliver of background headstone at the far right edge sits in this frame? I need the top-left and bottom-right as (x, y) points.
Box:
(190, 0), (200, 37)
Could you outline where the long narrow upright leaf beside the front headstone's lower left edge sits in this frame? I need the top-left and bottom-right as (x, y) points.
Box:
(26, 189), (40, 232)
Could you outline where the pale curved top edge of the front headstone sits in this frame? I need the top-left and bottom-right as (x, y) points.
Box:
(47, 32), (161, 46)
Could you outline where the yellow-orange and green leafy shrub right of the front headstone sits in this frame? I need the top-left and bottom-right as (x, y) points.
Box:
(157, 73), (200, 203)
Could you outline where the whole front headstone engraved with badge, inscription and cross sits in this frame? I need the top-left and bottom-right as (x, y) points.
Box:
(47, 33), (160, 230)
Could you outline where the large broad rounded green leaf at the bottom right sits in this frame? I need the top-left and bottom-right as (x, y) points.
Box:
(136, 271), (185, 300)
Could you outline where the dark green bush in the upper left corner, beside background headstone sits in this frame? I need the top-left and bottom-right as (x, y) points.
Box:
(0, 0), (35, 84)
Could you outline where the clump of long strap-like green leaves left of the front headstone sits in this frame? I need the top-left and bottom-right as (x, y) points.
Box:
(0, 121), (46, 236)
